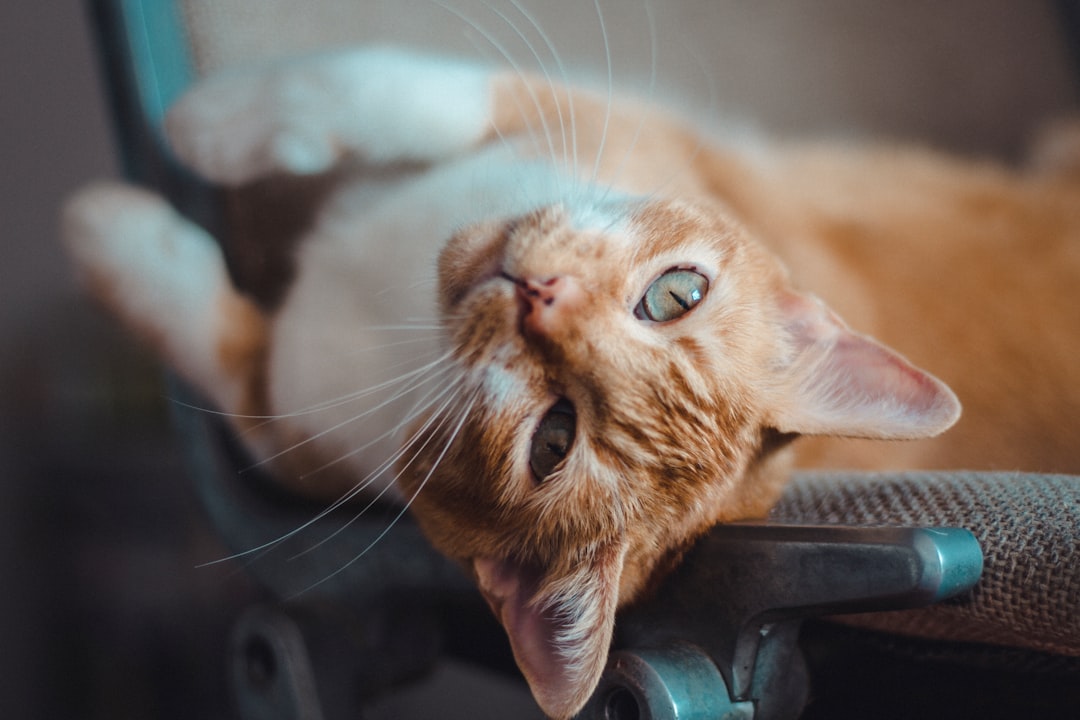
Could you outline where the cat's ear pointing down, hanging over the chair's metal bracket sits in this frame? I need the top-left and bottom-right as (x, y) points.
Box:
(473, 543), (625, 720)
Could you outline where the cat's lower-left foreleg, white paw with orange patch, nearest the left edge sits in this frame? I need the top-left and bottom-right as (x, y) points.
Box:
(62, 182), (267, 423)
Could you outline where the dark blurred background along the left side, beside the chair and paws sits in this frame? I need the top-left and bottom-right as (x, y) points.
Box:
(0, 5), (261, 719)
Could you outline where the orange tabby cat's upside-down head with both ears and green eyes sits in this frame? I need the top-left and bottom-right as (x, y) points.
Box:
(401, 195), (959, 717)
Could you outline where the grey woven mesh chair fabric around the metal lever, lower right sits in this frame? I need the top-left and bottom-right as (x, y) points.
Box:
(772, 473), (1080, 656)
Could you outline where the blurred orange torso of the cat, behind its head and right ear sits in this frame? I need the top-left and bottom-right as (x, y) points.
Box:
(720, 140), (1080, 472)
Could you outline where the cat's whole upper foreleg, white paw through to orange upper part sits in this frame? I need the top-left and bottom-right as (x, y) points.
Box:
(165, 49), (643, 185)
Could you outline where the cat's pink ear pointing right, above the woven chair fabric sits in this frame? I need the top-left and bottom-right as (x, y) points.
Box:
(772, 291), (960, 439)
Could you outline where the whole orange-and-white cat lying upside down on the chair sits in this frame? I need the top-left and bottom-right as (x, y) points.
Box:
(67, 51), (1080, 717)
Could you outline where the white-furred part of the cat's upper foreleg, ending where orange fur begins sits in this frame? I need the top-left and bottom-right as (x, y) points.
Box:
(166, 49), (491, 185)
